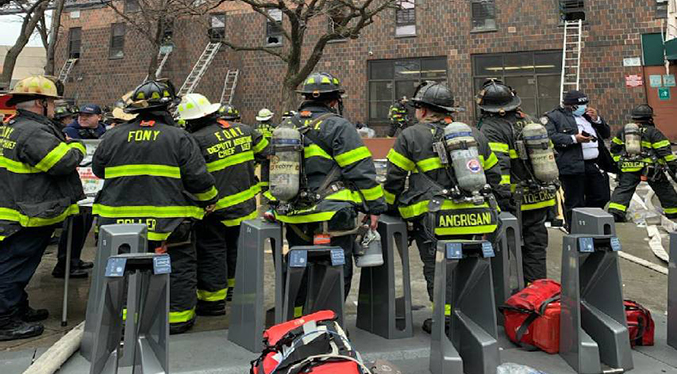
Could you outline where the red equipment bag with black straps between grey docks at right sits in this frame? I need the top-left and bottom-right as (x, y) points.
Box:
(500, 279), (562, 353)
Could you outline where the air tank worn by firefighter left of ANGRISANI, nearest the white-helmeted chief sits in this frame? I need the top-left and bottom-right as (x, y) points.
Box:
(269, 125), (303, 201)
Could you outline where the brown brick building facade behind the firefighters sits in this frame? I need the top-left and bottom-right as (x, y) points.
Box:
(56, 0), (677, 135)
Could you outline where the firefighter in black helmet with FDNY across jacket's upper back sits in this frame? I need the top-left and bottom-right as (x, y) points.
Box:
(92, 81), (218, 334)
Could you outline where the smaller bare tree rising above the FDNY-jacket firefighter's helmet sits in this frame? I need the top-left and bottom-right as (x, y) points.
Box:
(101, 0), (225, 79)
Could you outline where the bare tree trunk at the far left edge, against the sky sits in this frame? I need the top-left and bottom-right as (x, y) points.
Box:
(0, 0), (50, 89)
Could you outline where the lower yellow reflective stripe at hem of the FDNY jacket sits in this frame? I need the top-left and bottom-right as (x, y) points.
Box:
(92, 204), (204, 219)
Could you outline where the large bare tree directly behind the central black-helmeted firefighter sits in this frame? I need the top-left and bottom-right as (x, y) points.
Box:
(224, 0), (404, 108)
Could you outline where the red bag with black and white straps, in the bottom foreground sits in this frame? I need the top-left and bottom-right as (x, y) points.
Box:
(249, 310), (368, 374)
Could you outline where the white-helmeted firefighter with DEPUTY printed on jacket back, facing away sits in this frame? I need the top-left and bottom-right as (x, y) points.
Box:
(179, 94), (268, 316)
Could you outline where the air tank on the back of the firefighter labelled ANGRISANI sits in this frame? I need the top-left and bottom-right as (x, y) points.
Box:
(444, 122), (487, 193)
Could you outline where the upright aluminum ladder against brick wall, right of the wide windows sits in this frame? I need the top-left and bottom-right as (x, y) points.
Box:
(559, 19), (583, 103)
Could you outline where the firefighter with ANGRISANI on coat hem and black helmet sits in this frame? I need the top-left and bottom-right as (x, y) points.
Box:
(384, 81), (507, 333)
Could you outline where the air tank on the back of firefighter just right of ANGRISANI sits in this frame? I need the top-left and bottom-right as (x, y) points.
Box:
(522, 123), (559, 184)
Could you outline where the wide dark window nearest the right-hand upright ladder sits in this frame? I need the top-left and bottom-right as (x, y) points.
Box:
(472, 51), (562, 116)
